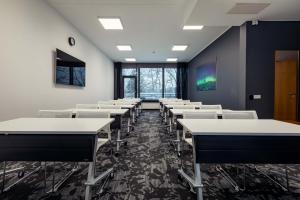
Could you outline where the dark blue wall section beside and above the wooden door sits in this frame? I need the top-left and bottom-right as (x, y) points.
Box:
(246, 21), (300, 118)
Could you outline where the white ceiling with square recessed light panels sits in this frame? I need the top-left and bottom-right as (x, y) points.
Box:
(46, 0), (300, 62)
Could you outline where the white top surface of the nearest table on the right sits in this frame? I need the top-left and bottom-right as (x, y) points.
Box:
(178, 119), (300, 136)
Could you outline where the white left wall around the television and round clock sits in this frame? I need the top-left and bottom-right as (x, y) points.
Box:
(0, 0), (113, 121)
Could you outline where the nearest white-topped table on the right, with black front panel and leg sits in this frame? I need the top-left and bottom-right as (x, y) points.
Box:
(178, 119), (300, 200)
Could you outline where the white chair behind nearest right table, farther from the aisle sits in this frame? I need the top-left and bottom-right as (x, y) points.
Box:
(216, 111), (258, 191)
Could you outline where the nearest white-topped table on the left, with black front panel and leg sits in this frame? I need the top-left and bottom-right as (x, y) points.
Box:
(0, 118), (114, 200)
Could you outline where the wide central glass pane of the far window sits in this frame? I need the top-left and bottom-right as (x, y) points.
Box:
(140, 68), (163, 100)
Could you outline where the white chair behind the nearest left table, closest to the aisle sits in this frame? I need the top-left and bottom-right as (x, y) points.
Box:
(76, 110), (113, 194)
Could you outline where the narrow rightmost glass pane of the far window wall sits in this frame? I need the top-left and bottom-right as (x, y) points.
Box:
(164, 68), (177, 98)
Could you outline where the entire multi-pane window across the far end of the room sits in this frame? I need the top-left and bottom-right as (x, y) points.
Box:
(122, 64), (177, 100)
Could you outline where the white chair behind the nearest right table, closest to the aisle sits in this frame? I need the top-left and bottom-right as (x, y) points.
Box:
(182, 110), (218, 146)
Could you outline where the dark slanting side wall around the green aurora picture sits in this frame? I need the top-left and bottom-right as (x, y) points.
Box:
(188, 27), (246, 109)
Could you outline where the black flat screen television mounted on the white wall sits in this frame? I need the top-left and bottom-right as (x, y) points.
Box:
(55, 49), (85, 87)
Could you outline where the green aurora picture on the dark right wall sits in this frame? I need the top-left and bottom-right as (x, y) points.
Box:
(196, 64), (217, 91)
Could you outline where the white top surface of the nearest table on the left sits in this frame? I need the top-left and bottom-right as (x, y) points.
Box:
(0, 118), (114, 134)
